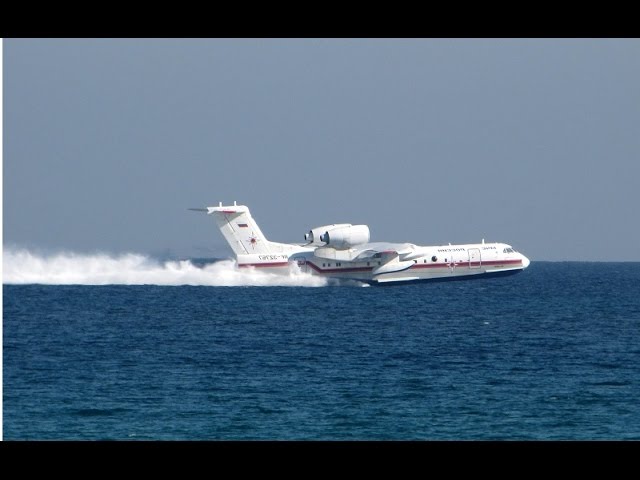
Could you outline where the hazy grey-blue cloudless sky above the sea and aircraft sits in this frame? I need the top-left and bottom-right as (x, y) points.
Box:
(3, 39), (640, 261)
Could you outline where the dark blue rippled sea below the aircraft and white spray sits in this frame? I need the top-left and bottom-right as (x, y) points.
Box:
(3, 262), (640, 440)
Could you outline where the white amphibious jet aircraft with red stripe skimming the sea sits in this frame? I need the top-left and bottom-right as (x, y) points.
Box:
(198, 202), (530, 284)
